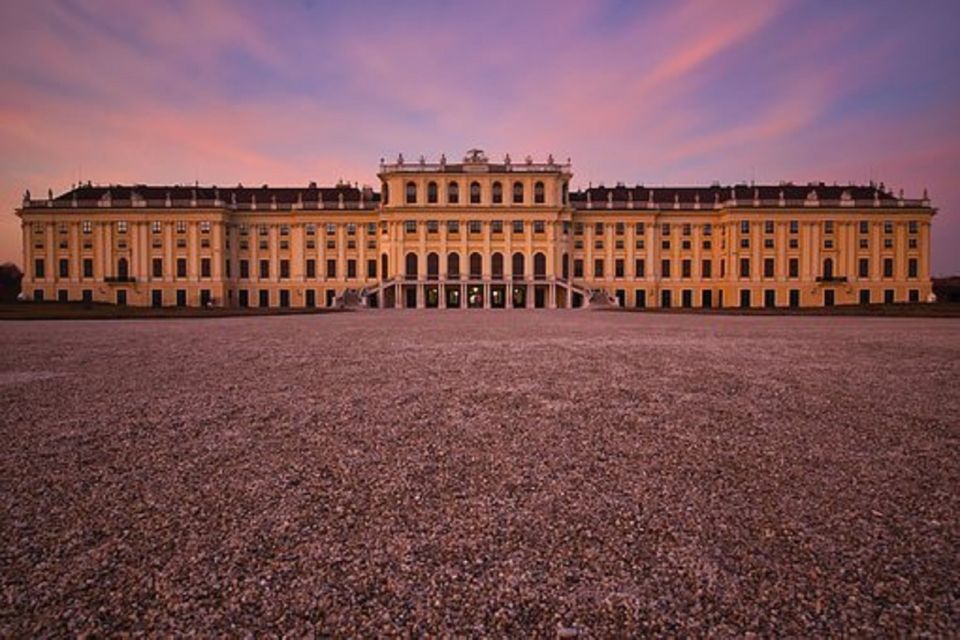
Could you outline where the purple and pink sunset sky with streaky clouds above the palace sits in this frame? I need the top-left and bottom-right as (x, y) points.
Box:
(0, 0), (960, 275)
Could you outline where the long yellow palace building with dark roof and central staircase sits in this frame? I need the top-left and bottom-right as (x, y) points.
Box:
(17, 150), (936, 309)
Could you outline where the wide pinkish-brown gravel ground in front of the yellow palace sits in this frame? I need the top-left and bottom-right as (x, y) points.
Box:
(0, 311), (960, 637)
